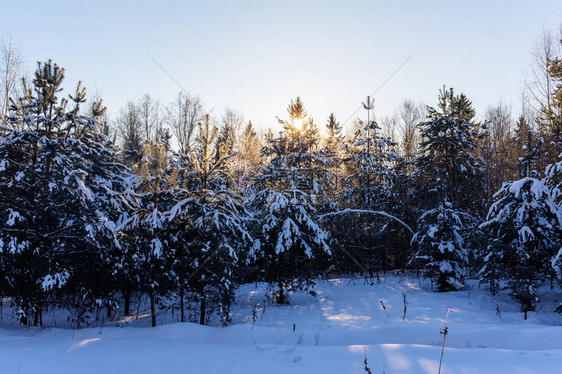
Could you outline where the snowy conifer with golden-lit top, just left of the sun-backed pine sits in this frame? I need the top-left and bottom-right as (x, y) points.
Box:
(169, 116), (252, 324)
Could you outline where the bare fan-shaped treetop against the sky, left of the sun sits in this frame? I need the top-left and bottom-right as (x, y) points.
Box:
(166, 92), (203, 155)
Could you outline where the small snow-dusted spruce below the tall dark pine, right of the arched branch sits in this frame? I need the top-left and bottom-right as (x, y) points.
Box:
(412, 201), (468, 292)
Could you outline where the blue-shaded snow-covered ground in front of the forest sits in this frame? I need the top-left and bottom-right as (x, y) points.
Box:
(0, 275), (562, 374)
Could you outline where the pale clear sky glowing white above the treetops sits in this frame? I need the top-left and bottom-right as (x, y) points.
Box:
(0, 0), (562, 133)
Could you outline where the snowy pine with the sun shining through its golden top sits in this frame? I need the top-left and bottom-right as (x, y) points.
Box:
(250, 98), (331, 304)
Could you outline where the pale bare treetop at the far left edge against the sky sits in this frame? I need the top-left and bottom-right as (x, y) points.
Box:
(0, 35), (24, 124)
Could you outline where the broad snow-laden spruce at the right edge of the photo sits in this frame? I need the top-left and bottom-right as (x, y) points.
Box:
(480, 133), (562, 318)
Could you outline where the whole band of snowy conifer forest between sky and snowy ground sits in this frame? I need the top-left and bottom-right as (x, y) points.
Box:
(0, 5), (562, 373)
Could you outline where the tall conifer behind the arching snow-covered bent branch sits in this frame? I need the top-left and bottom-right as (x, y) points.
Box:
(330, 115), (411, 276)
